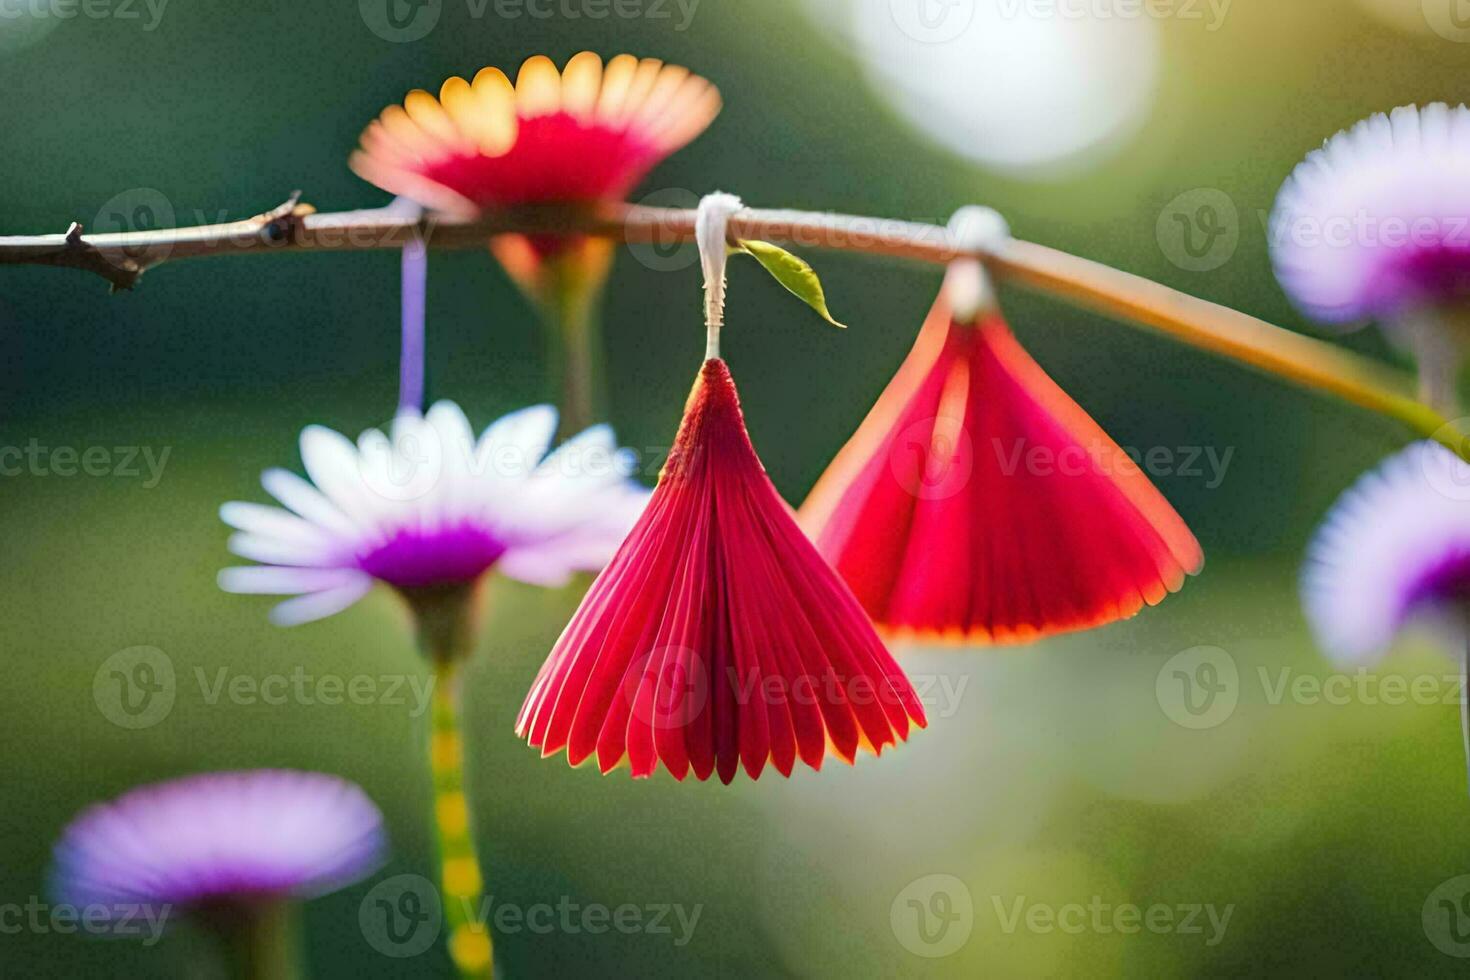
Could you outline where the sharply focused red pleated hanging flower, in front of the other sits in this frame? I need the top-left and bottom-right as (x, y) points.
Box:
(516, 359), (925, 783)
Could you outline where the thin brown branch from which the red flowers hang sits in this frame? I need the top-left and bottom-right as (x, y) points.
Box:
(0, 194), (1445, 435)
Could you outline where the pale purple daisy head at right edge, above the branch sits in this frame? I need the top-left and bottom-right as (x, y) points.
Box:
(1272, 103), (1470, 325)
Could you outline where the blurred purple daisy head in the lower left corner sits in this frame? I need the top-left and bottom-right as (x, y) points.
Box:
(53, 770), (387, 908)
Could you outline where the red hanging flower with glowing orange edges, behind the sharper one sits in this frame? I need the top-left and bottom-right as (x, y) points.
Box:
(801, 297), (1204, 644)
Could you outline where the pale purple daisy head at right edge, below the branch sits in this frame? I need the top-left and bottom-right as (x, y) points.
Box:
(1302, 442), (1470, 666)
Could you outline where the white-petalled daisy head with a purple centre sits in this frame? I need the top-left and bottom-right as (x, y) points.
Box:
(219, 401), (648, 626)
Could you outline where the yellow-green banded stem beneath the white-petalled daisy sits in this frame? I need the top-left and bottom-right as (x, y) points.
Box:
(429, 660), (495, 977)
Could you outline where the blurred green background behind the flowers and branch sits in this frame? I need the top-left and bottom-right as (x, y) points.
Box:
(0, 0), (1470, 977)
